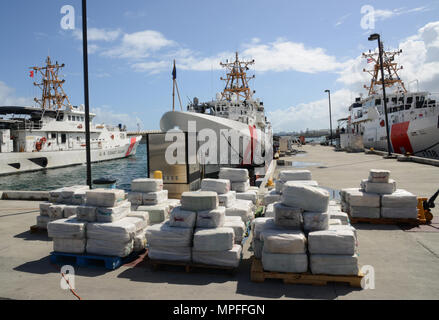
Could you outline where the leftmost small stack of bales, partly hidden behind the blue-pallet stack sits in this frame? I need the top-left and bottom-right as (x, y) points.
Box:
(37, 185), (89, 229)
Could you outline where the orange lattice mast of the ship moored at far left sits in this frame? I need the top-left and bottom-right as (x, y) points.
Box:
(31, 57), (72, 110)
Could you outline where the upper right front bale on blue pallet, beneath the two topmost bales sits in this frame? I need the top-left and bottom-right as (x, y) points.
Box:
(86, 218), (136, 242)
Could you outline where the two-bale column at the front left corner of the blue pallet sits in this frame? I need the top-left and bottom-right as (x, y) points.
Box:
(47, 218), (87, 254)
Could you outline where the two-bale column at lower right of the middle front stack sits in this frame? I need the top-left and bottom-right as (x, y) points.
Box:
(192, 227), (242, 268)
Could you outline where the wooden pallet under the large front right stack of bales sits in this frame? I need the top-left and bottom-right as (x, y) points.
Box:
(250, 257), (363, 288)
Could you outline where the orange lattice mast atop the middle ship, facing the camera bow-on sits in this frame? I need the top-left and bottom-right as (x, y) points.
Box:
(220, 52), (255, 101)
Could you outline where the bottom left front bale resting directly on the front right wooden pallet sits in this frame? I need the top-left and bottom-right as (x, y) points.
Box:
(262, 252), (308, 273)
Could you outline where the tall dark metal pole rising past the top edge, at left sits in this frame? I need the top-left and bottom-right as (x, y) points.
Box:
(82, 0), (92, 189)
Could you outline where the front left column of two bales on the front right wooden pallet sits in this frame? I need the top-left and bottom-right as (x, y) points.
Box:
(261, 230), (308, 273)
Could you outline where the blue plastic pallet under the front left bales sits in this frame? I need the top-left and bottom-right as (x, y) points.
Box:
(50, 251), (144, 270)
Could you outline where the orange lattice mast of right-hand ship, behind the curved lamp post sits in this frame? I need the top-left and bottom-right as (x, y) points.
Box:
(363, 45), (407, 96)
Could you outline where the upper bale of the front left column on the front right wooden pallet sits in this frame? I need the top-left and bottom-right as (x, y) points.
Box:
(261, 230), (306, 254)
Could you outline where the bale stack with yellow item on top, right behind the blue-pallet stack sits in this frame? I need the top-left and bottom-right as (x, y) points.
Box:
(128, 178), (171, 224)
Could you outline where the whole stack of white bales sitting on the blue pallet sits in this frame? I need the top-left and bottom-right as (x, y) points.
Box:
(48, 189), (148, 257)
